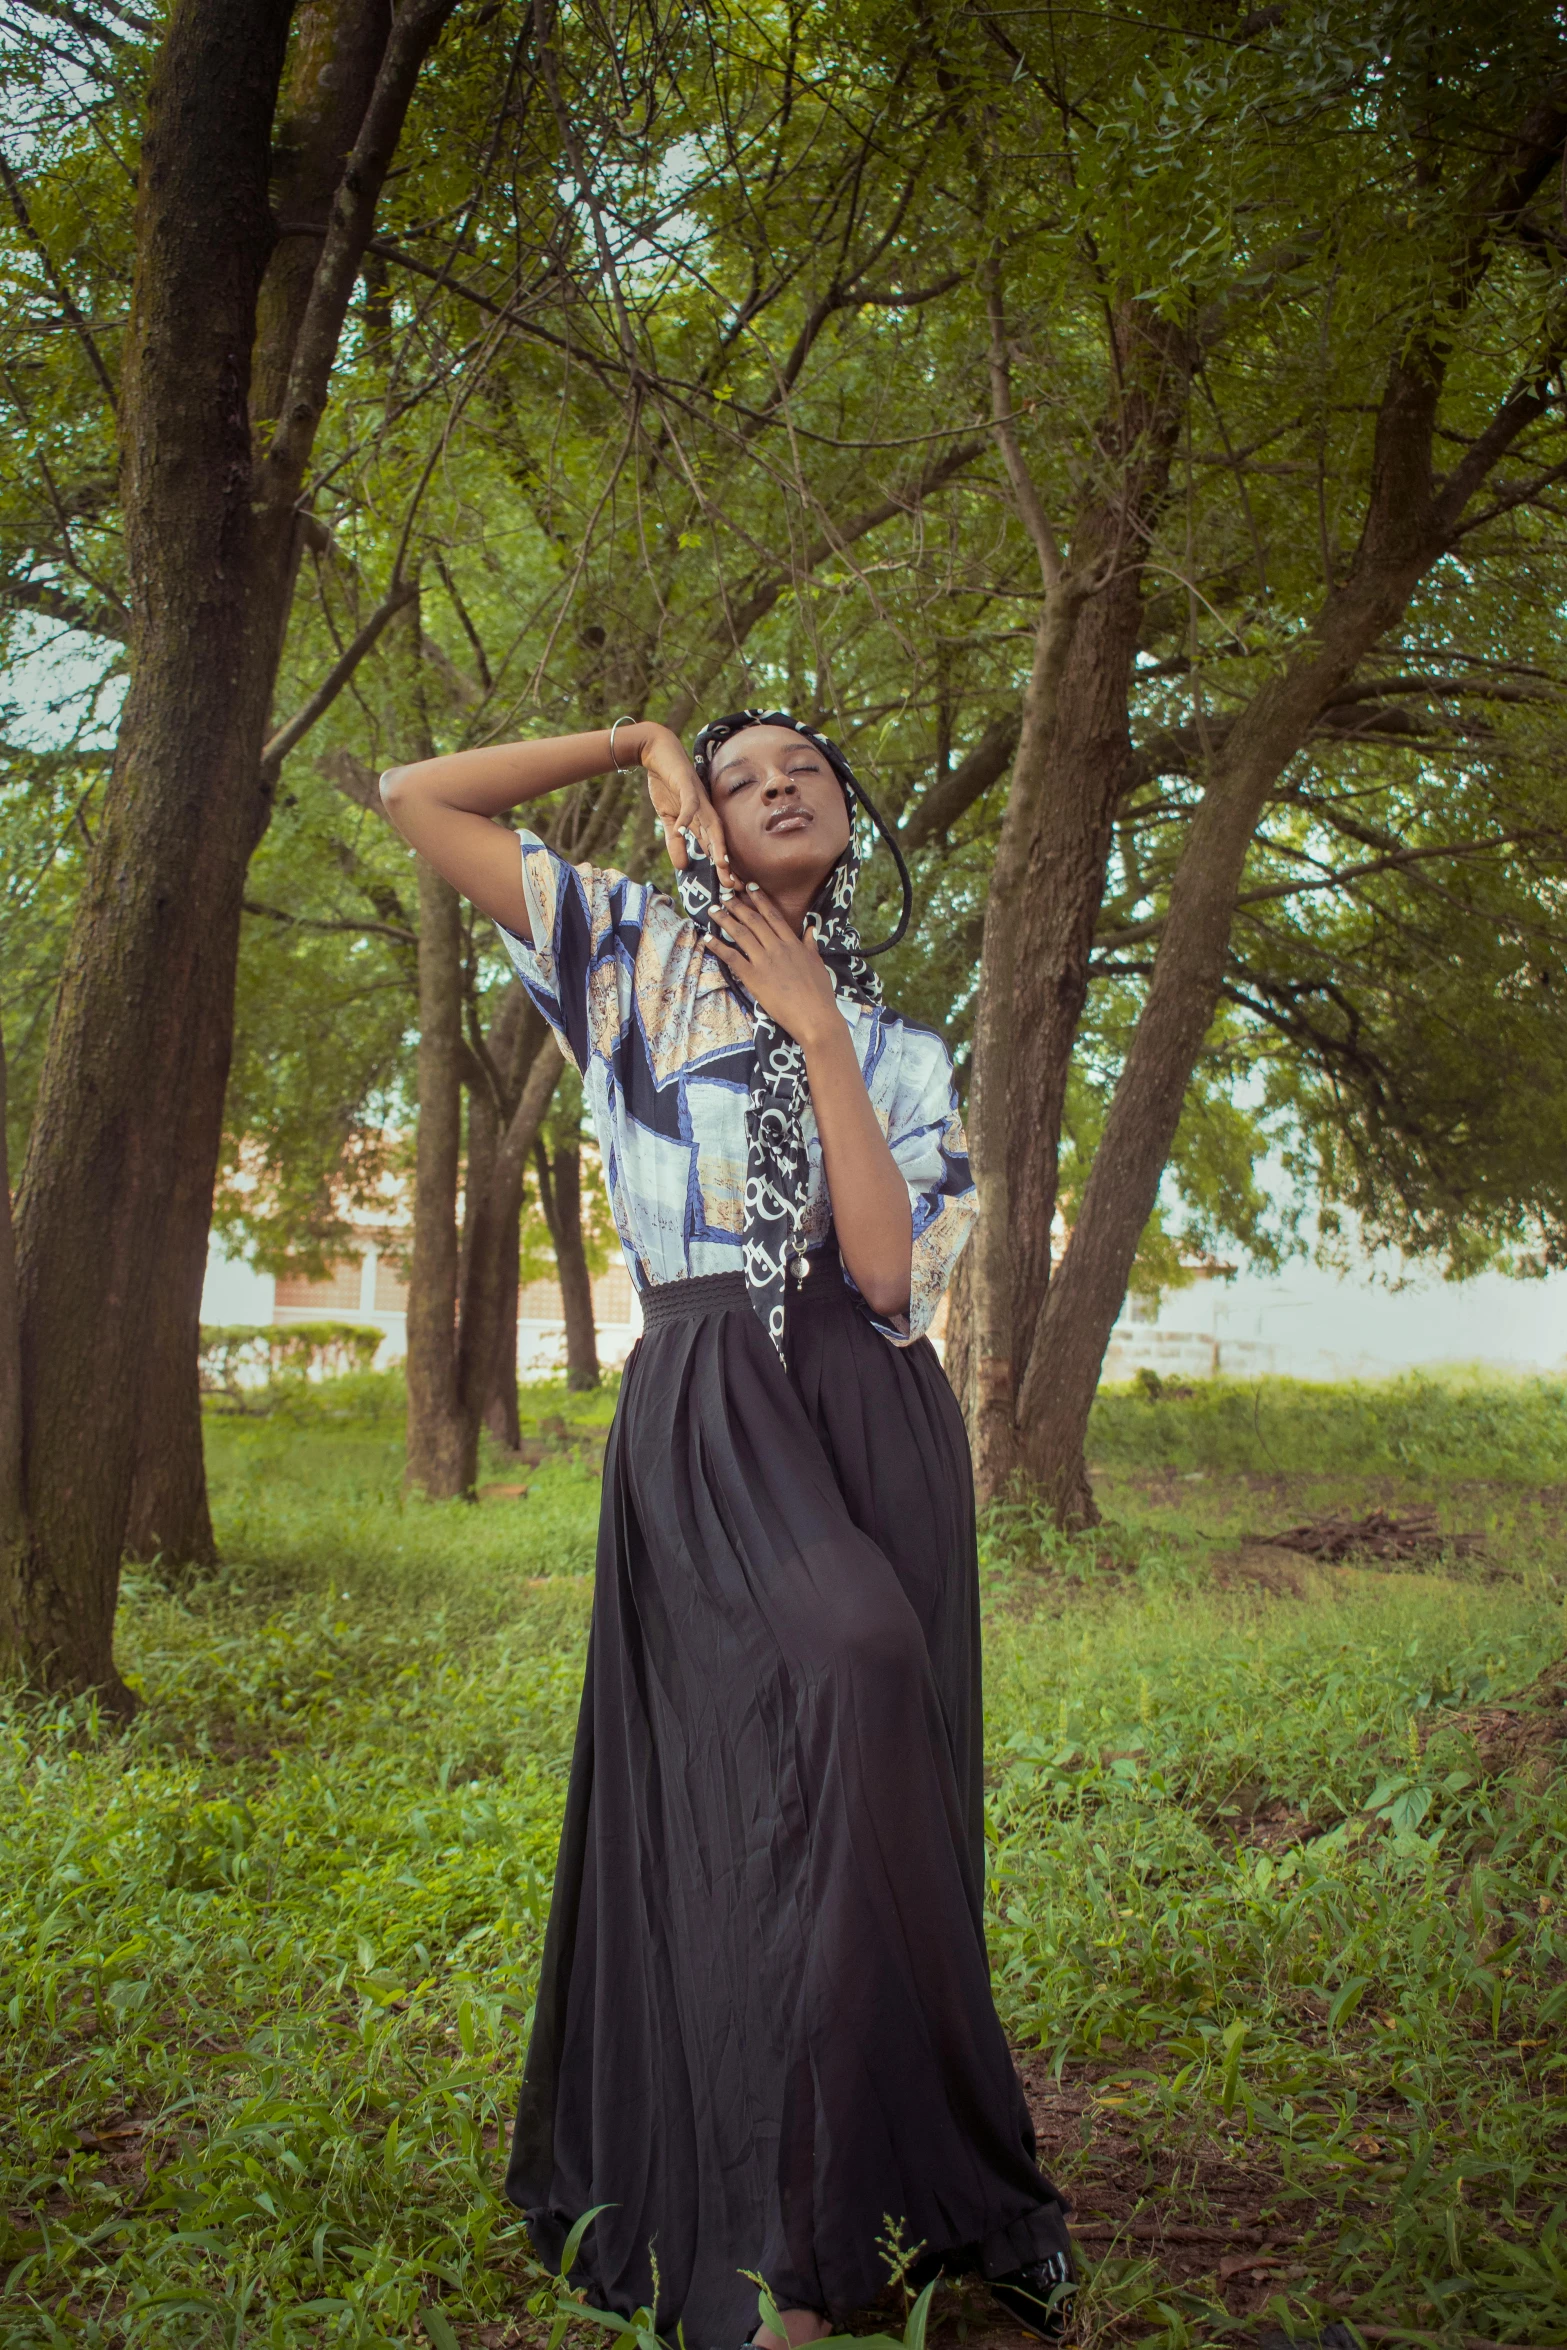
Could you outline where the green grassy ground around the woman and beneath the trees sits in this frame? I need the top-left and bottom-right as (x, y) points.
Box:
(0, 1377), (1567, 2350)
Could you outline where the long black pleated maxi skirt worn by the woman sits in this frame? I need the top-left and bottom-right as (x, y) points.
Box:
(505, 1250), (1067, 2350)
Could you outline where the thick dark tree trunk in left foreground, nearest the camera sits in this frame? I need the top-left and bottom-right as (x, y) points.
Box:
(0, 0), (451, 1711)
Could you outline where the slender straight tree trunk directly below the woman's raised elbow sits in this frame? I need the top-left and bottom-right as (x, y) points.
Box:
(404, 858), (469, 1502)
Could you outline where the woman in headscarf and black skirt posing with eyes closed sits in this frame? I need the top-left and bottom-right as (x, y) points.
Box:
(381, 712), (1071, 2350)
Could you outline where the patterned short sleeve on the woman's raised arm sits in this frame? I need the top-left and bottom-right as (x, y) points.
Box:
(496, 832), (651, 1074)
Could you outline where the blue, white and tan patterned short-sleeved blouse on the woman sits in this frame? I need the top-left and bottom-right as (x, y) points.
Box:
(500, 832), (977, 1347)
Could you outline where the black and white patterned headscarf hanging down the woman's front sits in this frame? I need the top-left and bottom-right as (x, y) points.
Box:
(674, 710), (912, 1358)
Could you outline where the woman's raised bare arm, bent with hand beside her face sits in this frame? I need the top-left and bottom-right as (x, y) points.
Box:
(381, 719), (728, 938)
